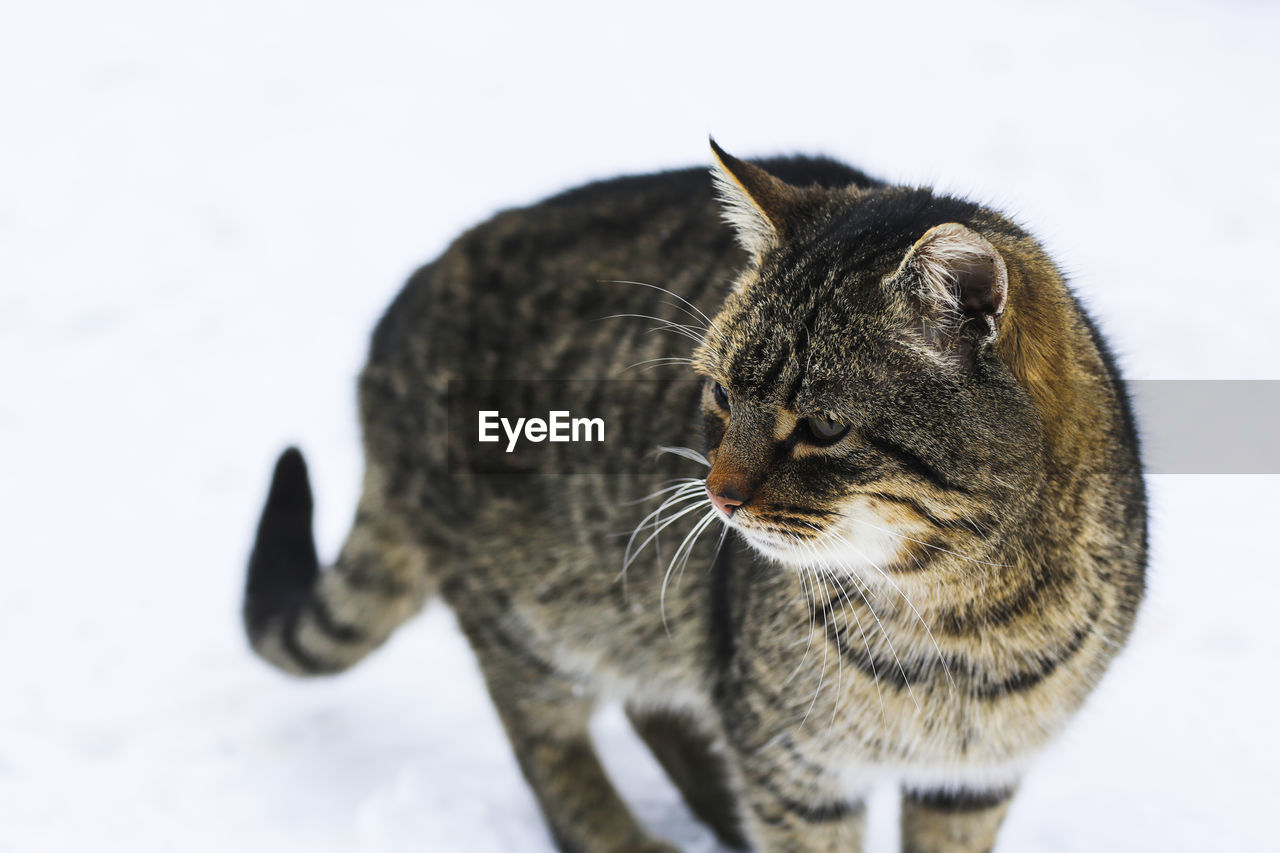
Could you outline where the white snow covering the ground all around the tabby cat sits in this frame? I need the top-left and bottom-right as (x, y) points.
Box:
(0, 0), (1280, 853)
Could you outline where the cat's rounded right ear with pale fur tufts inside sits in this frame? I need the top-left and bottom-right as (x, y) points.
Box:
(892, 222), (1009, 356)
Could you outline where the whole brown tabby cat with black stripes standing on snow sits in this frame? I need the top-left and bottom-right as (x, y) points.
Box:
(244, 141), (1147, 853)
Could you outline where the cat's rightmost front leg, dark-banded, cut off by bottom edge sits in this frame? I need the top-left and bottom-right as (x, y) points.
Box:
(902, 789), (1012, 853)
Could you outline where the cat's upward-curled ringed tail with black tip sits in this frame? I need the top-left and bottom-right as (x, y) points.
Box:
(243, 447), (431, 675)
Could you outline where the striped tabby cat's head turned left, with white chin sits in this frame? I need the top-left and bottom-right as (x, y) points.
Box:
(694, 142), (1043, 574)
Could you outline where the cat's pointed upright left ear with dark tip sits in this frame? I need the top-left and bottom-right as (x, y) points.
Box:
(710, 140), (801, 257)
